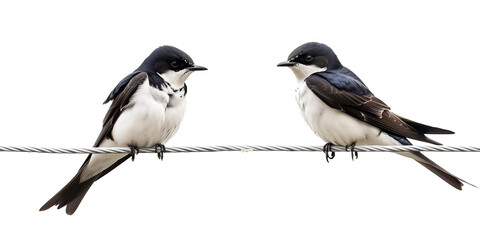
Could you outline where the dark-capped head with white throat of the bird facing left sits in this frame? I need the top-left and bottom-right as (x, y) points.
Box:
(277, 42), (342, 81)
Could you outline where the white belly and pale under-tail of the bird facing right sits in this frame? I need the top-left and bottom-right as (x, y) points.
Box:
(80, 79), (186, 181)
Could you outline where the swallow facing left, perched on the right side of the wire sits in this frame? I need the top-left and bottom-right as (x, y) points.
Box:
(277, 42), (474, 190)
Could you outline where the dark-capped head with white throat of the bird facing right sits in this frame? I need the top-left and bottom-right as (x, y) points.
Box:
(138, 46), (207, 88)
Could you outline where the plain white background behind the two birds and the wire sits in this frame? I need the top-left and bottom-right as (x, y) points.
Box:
(0, 0), (480, 239)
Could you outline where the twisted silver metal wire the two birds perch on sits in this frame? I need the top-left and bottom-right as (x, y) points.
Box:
(0, 145), (480, 154)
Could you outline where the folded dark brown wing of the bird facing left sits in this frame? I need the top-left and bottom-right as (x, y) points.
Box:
(305, 74), (447, 145)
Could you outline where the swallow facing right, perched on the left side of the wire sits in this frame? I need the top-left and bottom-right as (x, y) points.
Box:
(40, 45), (207, 215)
